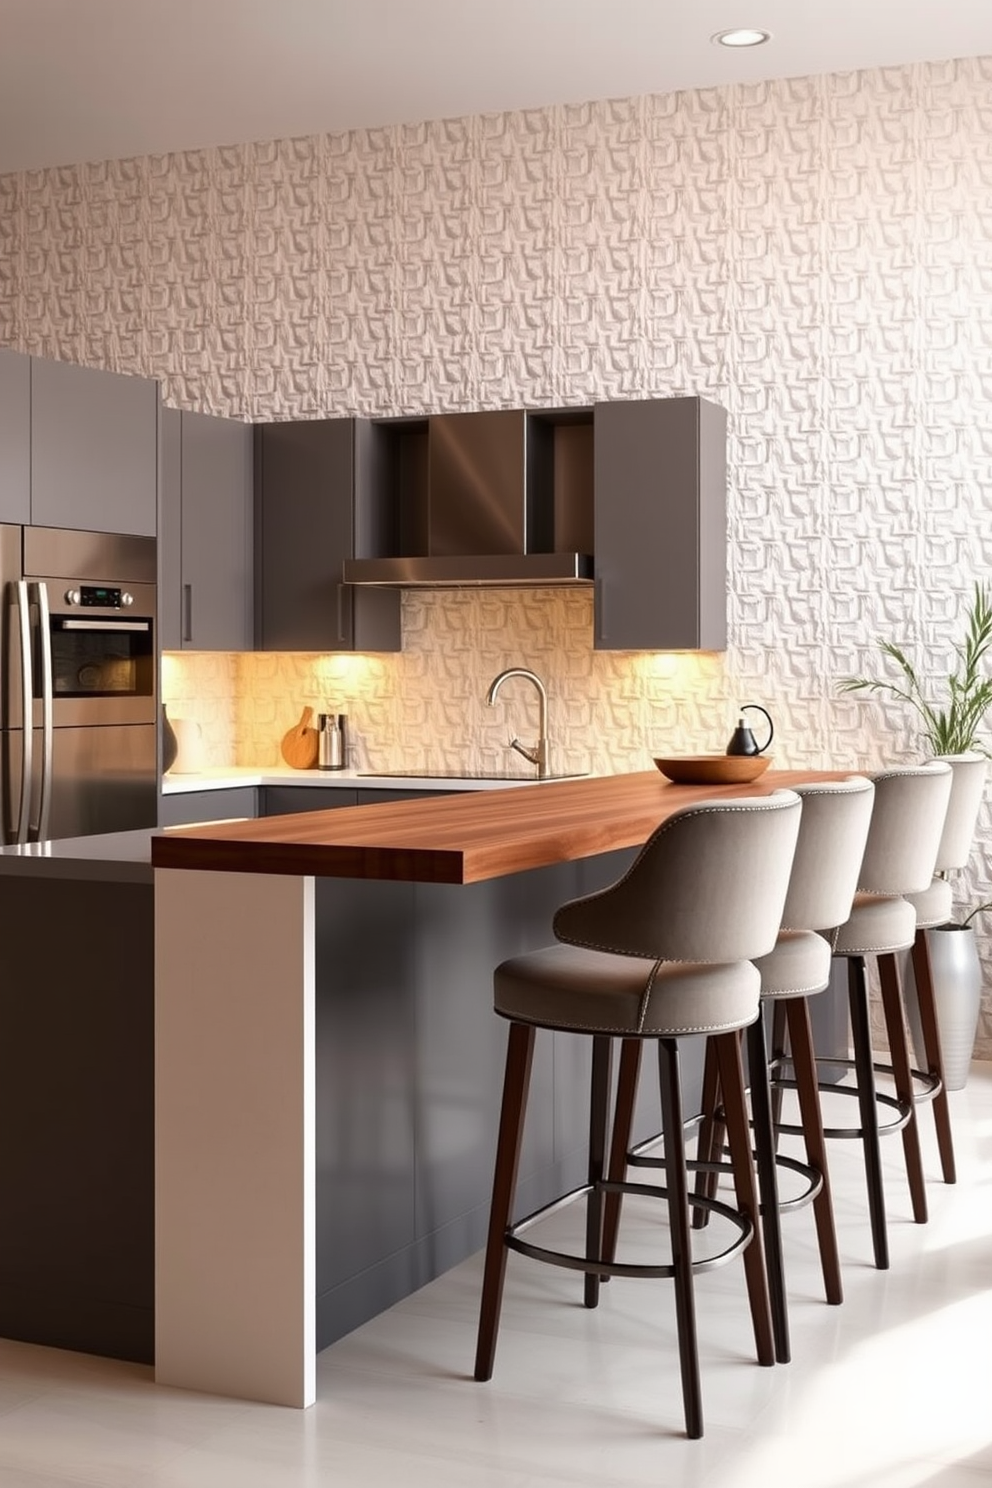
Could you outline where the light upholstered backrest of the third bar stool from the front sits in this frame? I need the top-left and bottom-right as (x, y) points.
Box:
(858, 760), (953, 894)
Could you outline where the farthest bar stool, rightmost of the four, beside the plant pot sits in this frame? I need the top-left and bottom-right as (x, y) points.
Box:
(906, 754), (988, 1183)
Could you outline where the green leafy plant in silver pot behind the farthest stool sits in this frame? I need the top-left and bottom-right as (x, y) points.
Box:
(840, 583), (992, 1091)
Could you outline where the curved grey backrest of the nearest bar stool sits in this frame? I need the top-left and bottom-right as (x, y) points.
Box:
(553, 790), (802, 961)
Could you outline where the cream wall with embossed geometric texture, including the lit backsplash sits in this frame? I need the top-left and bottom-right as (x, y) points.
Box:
(0, 58), (992, 1054)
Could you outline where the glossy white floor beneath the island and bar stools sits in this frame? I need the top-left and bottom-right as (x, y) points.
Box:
(0, 1065), (992, 1488)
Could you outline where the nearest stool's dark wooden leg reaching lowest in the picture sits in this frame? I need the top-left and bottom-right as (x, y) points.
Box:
(657, 1039), (704, 1437)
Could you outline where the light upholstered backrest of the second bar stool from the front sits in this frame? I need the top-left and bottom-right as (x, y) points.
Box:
(782, 775), (875, 930)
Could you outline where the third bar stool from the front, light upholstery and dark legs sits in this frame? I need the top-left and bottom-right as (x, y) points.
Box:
(772, 760), (952, 1271)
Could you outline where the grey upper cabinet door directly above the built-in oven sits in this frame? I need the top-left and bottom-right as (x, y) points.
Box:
(31, 357), (159, 537)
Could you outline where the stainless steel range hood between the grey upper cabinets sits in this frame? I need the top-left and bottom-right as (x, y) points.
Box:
(342, 409), (592, 588)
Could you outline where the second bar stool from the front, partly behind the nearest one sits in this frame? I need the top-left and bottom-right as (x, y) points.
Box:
(675, 775), (875, 1363)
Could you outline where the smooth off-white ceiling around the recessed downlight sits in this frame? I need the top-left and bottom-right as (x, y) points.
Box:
(0, 0), (992, 173)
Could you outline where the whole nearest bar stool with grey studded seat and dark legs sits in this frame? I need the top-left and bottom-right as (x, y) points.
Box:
(474, 792), (802, 1437)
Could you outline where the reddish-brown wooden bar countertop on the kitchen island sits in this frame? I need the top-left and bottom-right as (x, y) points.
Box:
(152, 766), (857, 884)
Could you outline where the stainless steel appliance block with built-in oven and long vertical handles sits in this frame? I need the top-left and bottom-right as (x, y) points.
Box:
(0, 527), (158, 842)
